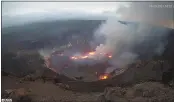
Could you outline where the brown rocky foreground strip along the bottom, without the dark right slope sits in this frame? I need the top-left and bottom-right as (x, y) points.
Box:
(2, 74), (174, 102)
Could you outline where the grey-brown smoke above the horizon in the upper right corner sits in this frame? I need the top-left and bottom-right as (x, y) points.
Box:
(116, 2), (174, 28)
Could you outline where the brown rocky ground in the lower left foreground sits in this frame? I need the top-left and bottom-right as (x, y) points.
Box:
(2, 77), (100, 102)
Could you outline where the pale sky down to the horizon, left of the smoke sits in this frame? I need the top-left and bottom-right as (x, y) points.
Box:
(2, 2), (127, 27)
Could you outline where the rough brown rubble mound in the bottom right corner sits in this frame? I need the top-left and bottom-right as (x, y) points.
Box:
(98, 82), (174, 102)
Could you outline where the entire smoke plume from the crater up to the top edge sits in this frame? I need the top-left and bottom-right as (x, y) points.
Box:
(92, 2), (174, 72)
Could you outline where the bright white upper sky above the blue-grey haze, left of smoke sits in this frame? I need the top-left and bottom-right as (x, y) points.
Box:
(2, 2), (127, 16)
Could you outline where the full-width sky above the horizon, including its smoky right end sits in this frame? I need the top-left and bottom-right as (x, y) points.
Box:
(2, 2), (174, 28)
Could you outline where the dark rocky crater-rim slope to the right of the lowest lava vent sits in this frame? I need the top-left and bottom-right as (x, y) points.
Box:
(112, 60), (172, 85)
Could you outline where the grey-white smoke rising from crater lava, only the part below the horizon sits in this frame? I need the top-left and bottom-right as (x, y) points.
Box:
(94, 19), (169, 68)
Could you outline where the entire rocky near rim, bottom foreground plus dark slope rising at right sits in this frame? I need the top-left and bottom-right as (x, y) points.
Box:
(2, 61), (174, 102)
